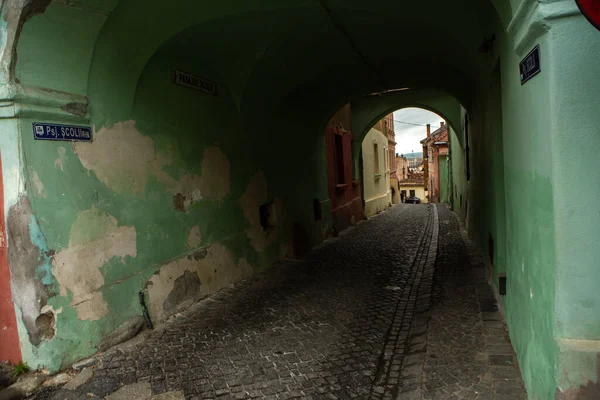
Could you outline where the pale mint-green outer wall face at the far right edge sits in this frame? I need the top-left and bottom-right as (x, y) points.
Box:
(546, 16), (600, 398)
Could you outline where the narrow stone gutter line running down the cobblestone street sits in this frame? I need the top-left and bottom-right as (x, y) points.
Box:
(370, 204), (439, 400)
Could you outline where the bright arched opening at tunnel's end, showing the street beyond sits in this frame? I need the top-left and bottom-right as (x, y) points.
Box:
(358, 107), (454, 212)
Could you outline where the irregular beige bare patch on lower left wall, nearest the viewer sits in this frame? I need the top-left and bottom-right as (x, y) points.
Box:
(52, 207), (137, 321)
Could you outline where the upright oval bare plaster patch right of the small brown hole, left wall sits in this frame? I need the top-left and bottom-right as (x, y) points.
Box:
(200, 146), (231, 200)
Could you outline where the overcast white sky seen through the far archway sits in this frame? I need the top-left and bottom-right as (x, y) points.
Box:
(394, 108), (444, 154)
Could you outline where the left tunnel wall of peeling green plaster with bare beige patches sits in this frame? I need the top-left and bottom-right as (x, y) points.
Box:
(10, 32), (302, 371)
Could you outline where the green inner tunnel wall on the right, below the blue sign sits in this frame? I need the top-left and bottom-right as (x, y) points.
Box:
(468, 24), (558, 399)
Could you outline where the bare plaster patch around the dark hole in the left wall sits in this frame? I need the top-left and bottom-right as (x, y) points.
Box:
(240, 171), (283, 252)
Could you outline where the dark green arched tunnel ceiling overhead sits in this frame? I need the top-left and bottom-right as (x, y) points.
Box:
(83, 0), (500, 129)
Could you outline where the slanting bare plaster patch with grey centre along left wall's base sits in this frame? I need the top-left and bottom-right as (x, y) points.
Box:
(147, 244), (252, 320)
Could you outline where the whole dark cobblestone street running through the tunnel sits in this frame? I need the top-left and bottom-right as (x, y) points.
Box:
(32, 205), (526, 400)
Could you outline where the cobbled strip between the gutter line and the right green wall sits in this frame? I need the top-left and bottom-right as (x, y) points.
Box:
(397, 205), (526, 400)
